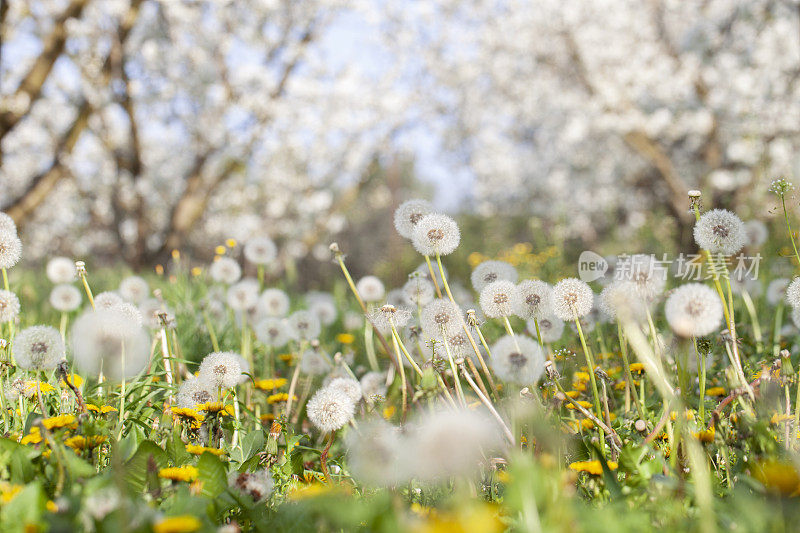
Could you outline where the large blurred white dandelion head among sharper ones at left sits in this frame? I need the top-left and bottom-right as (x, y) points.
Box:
(70, 309), (150, 381)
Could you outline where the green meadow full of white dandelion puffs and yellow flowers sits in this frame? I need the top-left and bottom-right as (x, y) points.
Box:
(0, 188), (800, 533)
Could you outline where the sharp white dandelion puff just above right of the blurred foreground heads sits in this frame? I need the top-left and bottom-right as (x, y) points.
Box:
(491, 335), (545, 385)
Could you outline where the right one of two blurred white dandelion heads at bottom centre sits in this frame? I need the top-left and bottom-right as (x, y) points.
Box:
(405, 409), (500, 481)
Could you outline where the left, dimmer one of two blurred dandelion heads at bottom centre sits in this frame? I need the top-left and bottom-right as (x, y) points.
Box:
(345, 418), (411, 487)
